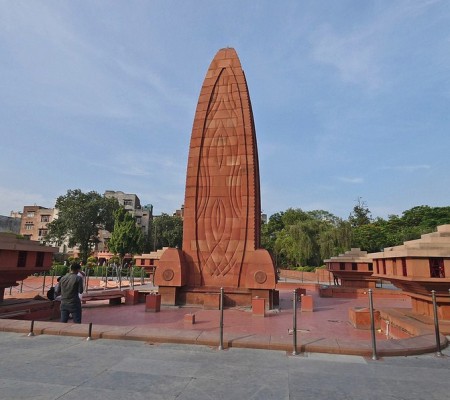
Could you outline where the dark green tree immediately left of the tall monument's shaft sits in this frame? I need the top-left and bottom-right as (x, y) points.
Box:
(150, 213), (183, 250)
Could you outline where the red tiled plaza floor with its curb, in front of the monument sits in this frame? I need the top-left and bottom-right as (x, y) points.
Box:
(0, 281), (447, 356)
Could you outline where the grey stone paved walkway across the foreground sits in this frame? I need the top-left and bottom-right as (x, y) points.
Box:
(0, 332), (450, 400)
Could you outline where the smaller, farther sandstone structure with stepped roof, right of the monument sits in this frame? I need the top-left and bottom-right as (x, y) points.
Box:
(325, 248), (378, 288)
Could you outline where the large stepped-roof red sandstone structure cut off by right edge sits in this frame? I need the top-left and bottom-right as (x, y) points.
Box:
(370, 225), (450, 320)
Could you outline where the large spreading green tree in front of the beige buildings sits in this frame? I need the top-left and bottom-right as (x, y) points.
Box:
(46, 189), (119, 263)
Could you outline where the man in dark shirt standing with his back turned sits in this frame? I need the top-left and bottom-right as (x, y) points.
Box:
(55, 263), (83, 324)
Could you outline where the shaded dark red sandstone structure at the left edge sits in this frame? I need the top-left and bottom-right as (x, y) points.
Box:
(0, 233), (58, 301)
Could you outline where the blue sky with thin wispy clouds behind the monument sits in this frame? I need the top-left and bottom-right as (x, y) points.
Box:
(0, 0), (450, 218)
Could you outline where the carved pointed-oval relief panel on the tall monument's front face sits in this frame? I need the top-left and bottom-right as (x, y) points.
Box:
(196, 68), (248, 276)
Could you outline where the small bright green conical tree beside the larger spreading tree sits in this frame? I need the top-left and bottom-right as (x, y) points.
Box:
(108, 207), (143, 266)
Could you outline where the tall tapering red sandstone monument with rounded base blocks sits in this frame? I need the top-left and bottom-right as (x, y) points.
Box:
(155, 48), (277, 308)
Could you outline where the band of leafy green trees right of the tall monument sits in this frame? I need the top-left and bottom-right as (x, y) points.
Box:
(261, 202), (450, 267)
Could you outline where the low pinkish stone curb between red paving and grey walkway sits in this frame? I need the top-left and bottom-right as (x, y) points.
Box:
(0, 319), (448, 357)
